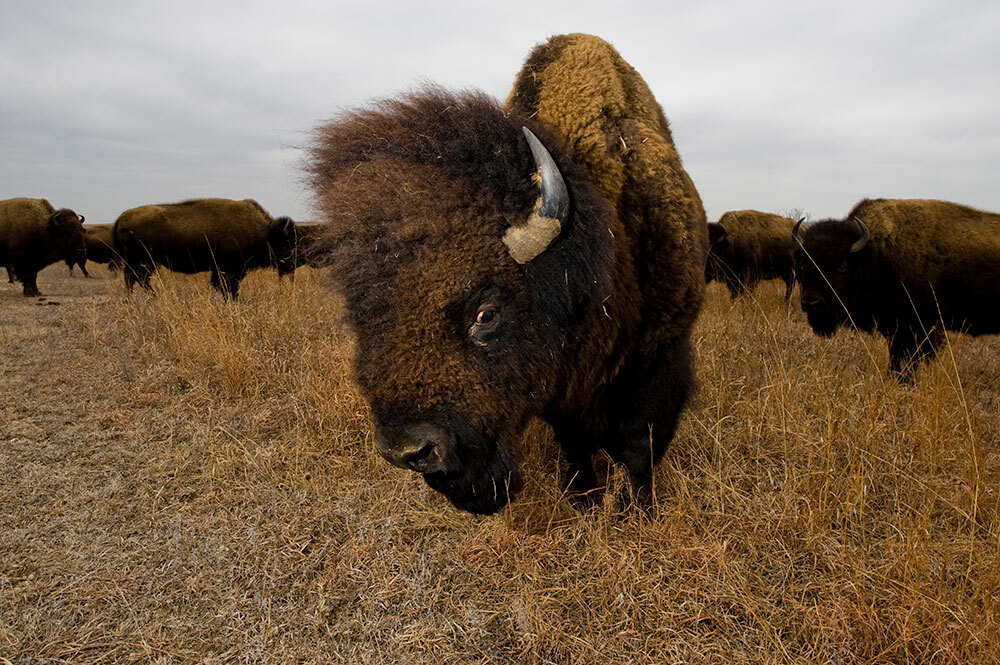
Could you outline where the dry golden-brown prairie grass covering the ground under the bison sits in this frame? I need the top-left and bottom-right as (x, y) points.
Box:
(0, 265), (1000, 665)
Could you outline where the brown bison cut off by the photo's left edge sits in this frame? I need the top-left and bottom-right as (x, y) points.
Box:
(0, 198), (87, 296)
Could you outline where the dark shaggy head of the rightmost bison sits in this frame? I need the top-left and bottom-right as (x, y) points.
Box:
(792, 218), (872, 337)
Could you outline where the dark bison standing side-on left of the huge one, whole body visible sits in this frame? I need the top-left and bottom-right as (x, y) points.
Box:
(114, 199), (295, 298)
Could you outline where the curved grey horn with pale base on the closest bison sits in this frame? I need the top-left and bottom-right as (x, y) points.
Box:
(503, 127), (569, 264)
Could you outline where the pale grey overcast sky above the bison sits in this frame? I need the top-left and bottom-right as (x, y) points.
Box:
(0, 0), (1000, 222)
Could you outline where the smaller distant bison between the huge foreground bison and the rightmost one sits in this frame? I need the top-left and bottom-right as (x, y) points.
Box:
(705, 210), (798, 301)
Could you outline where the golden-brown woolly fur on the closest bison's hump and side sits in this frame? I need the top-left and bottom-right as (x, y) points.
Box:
(506, 34), (708, 337)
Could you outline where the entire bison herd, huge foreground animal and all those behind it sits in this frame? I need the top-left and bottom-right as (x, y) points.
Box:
(0, 34), (1000, 513)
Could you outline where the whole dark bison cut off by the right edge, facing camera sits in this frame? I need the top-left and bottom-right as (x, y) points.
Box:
(794, 199), (1000, 378)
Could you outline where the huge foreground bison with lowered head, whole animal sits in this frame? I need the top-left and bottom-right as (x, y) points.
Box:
(309, 34), (707, 513)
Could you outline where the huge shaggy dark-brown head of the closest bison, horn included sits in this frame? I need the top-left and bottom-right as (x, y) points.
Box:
(309, 89), (613, 514)
